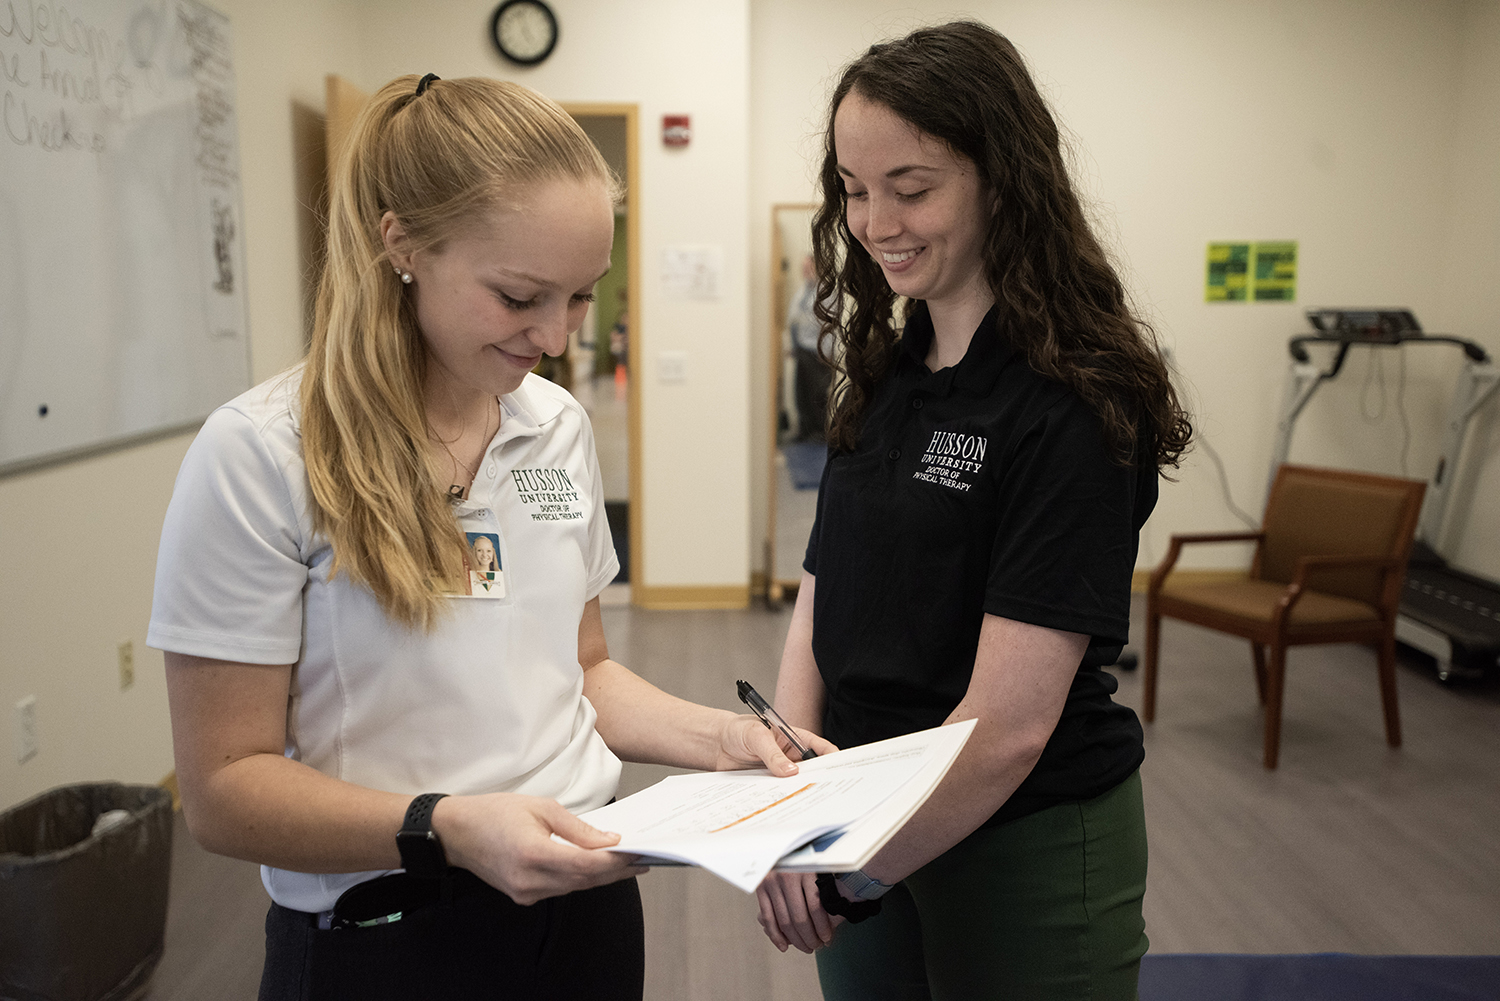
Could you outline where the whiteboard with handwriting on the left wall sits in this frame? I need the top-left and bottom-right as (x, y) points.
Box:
(0, 0), (251, 474)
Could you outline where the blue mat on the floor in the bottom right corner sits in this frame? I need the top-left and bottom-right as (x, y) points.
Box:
(1140, 953), (1500, 1001)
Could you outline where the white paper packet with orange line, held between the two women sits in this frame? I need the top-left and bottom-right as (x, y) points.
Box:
(570, 720), (974, 893)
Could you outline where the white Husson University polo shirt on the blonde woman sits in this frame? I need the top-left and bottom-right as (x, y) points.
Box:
(147, 369), (620, 911)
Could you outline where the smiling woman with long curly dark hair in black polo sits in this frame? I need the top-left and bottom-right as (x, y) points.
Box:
(759, 21), (1193, 999)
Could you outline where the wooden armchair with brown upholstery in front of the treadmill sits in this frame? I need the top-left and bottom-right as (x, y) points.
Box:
(1145, 465), (1425, 768)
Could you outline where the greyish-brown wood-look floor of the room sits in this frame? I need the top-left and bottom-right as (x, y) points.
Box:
(141, 608), (1500, 1001)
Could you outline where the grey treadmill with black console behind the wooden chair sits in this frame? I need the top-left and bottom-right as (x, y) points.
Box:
(1271, 309), (1500, 683)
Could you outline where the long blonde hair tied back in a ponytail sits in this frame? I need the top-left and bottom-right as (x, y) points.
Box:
(302, 75), (611, 630)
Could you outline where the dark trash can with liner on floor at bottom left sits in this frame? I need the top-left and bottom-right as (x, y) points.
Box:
(0, 782), (173, 1001)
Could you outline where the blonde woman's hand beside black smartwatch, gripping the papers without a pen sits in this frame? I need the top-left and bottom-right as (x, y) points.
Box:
(432, 792), (647, 905)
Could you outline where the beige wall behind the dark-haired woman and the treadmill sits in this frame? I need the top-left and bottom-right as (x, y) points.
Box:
(750, 0), (1500, 578)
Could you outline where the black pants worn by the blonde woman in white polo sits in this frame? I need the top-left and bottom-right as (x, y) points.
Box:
(260, 872), (645, 1001)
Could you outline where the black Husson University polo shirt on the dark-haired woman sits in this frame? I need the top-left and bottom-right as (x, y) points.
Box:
(803, 303), (1157, 824)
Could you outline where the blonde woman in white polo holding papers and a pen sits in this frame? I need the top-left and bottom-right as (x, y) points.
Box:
(150, 75), (828, 999)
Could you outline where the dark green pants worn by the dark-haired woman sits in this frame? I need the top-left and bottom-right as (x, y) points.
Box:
(818, 773), (1146, 1001)
